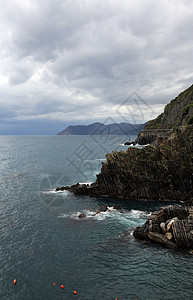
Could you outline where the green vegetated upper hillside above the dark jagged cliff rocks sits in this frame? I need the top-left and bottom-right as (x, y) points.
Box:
(136, 85), (193, 145)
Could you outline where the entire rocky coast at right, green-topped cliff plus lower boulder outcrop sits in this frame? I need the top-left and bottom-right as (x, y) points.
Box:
(56, 85), (193, 249)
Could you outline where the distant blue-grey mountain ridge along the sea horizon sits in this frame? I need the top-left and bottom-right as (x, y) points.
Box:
(57, 122), (145, 135)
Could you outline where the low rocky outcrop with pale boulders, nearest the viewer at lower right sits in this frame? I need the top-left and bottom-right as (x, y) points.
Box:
(133, 203), (193, 249)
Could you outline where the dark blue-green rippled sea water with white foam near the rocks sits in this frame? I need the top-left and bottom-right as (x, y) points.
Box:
(0, 136), (193, 300)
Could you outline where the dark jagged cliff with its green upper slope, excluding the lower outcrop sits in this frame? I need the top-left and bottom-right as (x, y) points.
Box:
(62, 86), (193, 200)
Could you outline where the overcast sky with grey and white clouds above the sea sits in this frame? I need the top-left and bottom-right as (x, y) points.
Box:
(0, 0), (193, 134)
